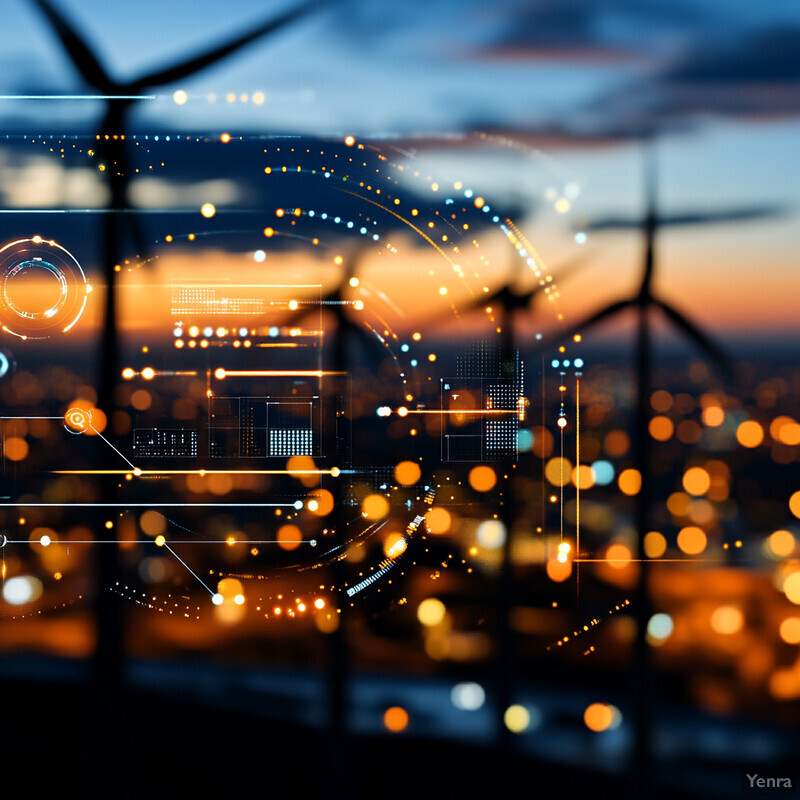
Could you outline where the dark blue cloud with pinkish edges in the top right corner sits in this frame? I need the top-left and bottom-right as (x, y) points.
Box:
(462, 5), (800, 141)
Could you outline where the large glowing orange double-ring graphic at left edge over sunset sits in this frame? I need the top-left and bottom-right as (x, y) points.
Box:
(0, 236), (91, 339)
